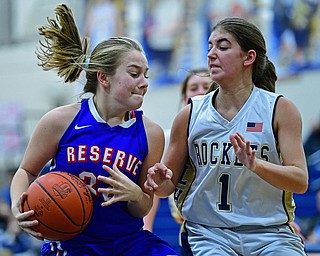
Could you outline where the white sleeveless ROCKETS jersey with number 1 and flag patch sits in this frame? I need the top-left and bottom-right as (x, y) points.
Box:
(175, 87), (295, 228)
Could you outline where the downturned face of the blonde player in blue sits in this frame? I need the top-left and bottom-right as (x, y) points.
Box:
(110, 51), (149, 111)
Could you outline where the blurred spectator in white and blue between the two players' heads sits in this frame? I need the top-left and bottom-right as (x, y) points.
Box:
(144, 0), (184, 84)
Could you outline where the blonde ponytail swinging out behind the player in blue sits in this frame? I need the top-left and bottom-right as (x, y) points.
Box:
(36, 4), (90, 82)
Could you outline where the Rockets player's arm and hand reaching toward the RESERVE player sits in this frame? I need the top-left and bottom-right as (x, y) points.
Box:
(145, 105), (191, 197)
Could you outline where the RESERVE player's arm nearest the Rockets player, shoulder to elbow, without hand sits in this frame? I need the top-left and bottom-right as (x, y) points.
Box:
(128, 116), (164, 217)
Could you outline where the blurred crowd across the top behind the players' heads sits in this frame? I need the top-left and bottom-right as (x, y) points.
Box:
(0, 0), (320, 86)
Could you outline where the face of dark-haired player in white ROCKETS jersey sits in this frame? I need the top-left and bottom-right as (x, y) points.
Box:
(207, 29), (245, 85)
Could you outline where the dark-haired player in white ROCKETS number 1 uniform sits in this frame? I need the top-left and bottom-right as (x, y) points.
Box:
(145, 18), (308, 256)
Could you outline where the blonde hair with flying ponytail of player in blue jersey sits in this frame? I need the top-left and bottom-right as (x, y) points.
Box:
(36, 4), (145, 94)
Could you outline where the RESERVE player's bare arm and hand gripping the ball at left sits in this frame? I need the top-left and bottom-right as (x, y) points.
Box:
(10, 105), (79, 235)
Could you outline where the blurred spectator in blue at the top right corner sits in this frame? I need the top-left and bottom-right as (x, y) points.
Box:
(272, 0), (319, 77)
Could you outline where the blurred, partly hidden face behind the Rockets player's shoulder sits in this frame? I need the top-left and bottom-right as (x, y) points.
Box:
(184, 74), (211, 103)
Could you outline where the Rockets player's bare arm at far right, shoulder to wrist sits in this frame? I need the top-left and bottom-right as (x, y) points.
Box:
(250, 97), (308, 193)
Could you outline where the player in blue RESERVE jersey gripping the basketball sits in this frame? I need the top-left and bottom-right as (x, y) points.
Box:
(11, 4), (177, 256)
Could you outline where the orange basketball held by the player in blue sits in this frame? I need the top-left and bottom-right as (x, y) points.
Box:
(22, 172), (93, 241)
